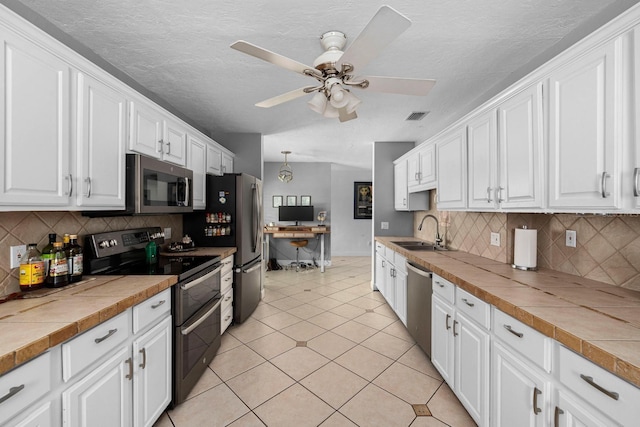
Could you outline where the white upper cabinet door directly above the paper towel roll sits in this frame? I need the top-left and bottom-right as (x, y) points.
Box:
(495, 83), (544, 208)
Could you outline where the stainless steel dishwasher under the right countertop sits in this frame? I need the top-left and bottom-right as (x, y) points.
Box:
(407, 261), (433, 357)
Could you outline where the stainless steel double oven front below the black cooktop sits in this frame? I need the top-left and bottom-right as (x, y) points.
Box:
(172, 263), (222, 406)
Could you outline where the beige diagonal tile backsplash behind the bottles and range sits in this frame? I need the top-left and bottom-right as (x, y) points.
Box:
(0, 211), (182, 297)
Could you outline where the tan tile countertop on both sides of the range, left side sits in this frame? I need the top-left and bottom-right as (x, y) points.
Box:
(0, 247), (236, 375)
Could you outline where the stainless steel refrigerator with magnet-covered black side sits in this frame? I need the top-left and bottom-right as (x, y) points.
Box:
(183, 173), (263, 323)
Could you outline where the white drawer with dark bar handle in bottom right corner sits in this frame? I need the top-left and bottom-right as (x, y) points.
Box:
(557, 344), (640, 426)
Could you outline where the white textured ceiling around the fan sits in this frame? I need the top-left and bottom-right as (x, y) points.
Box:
(10, 0), (637, 168)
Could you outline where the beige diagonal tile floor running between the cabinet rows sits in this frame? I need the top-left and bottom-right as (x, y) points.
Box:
(156, 257), (475, 427)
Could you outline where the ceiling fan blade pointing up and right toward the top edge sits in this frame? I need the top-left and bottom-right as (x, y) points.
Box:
(336, 6), (411, 70)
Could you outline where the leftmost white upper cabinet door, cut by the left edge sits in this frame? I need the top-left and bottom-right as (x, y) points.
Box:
(0, 28), (74, 207)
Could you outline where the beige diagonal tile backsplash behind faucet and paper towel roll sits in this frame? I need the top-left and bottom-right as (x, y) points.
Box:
(413, 191), (640, 290)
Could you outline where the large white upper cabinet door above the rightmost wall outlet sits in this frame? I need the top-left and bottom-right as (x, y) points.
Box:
(549, 38), (622, 209)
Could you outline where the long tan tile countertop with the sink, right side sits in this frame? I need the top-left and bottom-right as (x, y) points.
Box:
(376, 237), (640, 387)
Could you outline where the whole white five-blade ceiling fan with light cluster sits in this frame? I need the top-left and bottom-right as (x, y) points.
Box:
(231, 6), (436, 122)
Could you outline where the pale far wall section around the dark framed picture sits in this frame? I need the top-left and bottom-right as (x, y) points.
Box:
(329, 165), (373, 256)
